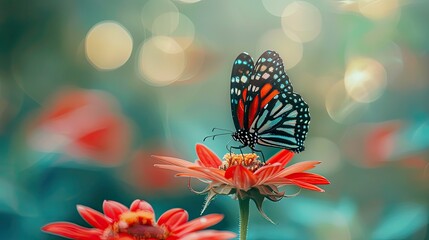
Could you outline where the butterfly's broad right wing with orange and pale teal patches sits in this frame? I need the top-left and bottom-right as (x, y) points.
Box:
(245, 51), (310, 152)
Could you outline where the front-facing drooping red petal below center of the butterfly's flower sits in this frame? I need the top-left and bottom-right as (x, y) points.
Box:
(225, 165), (256, 191)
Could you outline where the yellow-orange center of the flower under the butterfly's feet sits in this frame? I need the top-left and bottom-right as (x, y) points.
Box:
(219, 153), (265, 172)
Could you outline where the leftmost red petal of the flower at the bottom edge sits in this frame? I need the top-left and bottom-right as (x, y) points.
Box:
(42, 222), (103, 240)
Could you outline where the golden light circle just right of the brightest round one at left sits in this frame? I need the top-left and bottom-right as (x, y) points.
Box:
(138, 36), (186, 86)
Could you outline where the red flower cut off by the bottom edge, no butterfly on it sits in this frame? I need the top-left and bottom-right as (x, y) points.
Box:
(42, 200), (235, 240)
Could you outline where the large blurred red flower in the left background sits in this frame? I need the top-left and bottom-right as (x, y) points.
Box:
(28, 89), (130, 164)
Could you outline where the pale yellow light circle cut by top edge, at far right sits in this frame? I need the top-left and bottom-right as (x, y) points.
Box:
(359, 0), (400, 20)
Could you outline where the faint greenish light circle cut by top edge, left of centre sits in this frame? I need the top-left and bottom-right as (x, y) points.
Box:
(141, 0), (179, 31)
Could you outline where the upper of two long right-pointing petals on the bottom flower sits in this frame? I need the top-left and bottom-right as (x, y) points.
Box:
(171, 214), (223, 237)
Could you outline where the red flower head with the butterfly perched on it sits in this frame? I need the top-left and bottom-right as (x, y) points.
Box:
(155, 144), (329, 219)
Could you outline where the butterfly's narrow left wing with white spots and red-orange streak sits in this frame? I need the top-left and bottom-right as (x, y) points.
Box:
(230, 53), (254, 130)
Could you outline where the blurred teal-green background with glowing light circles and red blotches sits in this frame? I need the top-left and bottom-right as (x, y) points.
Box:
(0, 0), (429, 240)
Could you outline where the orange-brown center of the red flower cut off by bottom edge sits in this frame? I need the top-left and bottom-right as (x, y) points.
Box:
(103, 211), (168, 239)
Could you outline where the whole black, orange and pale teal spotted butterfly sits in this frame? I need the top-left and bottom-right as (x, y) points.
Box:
(230, 51), (310, 152)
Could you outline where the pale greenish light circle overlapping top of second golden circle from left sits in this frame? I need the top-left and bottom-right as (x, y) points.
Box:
(152, 12), (195, 48)
